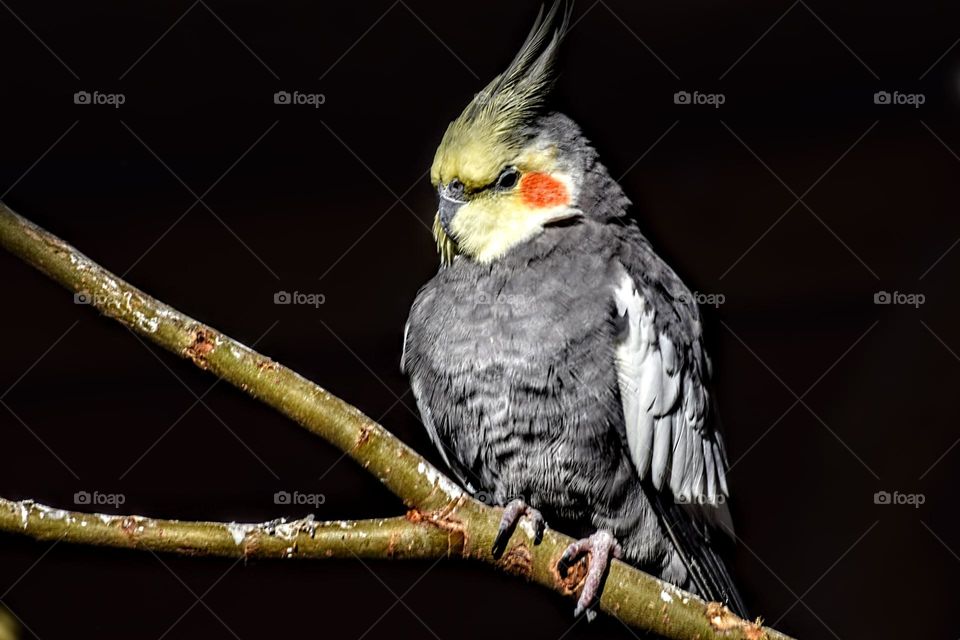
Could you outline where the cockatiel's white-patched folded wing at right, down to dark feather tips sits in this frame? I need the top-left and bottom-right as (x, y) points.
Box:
(614, 269), (746, 616)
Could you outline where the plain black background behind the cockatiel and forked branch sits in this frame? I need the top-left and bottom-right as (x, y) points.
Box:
(0, 0), (960, 640)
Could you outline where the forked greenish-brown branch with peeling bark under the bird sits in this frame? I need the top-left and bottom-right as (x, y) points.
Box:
(0, 204), (787, 640)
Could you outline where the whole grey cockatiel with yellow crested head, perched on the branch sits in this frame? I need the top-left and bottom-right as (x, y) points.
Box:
(401, 4), (746, 615)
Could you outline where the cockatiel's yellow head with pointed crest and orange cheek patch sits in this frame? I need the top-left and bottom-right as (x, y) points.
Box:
(430, 3), (576, 264)
